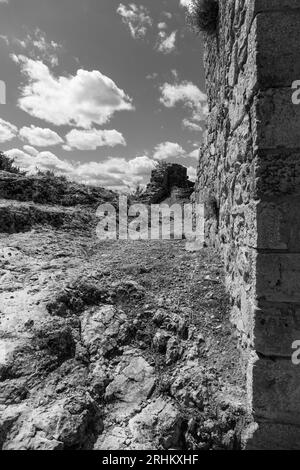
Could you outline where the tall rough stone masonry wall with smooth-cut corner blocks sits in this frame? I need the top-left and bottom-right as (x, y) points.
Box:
(196, 0), (300, 449)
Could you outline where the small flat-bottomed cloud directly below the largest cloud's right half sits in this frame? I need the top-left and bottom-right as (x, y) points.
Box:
(65, 129), (126, 150)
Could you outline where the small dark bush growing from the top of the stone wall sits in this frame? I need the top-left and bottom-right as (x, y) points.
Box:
(188, 0), (219, 34)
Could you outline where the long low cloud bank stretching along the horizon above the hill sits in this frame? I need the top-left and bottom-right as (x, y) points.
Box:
(5, 146), (155, 190)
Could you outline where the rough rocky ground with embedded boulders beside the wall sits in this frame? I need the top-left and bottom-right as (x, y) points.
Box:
(0, 208), (245, 450)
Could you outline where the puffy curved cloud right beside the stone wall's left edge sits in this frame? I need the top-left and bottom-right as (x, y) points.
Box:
(160, 81), (208, 130)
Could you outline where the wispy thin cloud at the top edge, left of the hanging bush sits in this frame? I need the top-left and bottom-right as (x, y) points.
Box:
(117, 3), (152, 39)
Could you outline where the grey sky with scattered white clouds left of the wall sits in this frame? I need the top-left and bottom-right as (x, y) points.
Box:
(0, 0), (207, 190)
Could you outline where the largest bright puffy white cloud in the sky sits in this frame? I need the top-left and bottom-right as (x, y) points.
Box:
(12, 56), (134, 129)
